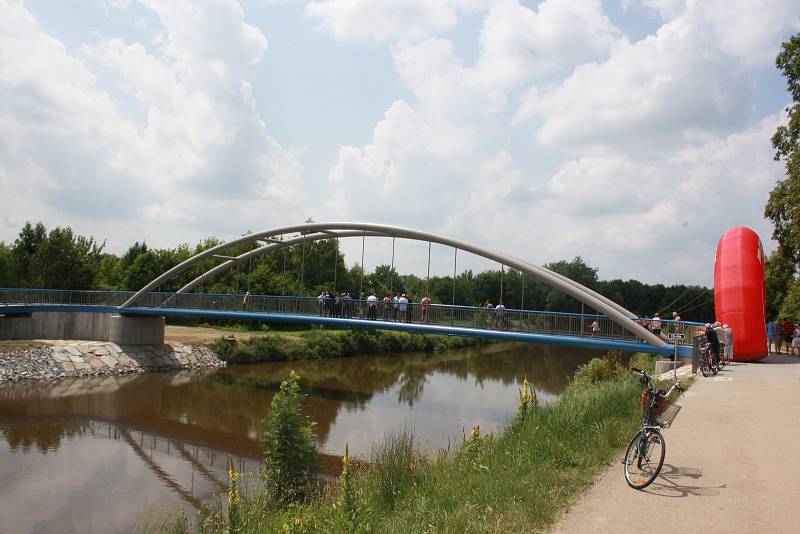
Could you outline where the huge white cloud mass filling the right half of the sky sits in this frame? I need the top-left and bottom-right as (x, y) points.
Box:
(330, 1), (780, 284)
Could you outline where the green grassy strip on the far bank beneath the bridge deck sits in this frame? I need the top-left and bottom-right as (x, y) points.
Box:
(211, 329), (488, 364)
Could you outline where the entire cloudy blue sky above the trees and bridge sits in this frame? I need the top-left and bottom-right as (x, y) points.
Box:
(0, 0), (800, 286)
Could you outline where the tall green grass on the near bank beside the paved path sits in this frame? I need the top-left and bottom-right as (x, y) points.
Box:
(145, 357), (668, 533)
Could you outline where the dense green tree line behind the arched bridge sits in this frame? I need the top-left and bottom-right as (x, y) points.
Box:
(0, 222), (714, 321)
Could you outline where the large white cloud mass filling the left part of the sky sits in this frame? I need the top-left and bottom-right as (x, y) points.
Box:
(0, 0), (302, 247)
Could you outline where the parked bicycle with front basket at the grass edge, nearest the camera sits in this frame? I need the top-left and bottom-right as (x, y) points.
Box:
(622, 369), (684, 489)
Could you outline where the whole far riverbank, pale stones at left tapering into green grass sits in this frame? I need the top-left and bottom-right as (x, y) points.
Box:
(0, 327), (489, 383)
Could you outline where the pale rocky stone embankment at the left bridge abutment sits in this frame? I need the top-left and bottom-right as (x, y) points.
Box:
(0, 341), (225, 382)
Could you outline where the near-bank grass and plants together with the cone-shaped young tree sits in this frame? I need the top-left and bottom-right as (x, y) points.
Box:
(139, 353), (654, 533)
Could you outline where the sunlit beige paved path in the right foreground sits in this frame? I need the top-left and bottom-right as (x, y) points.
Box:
(554, 356), (800, 534)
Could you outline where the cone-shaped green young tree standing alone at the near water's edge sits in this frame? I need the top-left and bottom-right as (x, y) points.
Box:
(263, 371), (321, 504)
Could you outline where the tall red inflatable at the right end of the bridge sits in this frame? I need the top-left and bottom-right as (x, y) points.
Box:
(714, 226), (767, 362)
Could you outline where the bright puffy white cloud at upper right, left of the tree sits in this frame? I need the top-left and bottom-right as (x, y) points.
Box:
(517, 19), (753, 147)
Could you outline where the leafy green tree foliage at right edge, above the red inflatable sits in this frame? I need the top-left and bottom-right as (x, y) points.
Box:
(764, 34), (800, 268)
